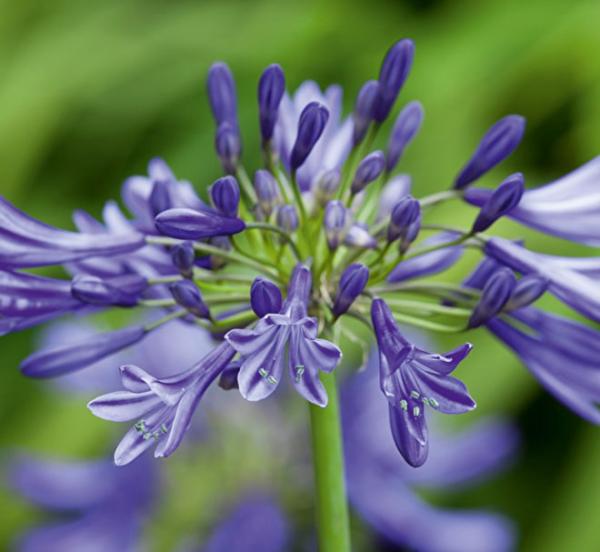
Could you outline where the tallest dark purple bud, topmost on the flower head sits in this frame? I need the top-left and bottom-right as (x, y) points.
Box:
(373, 38), (415, 123)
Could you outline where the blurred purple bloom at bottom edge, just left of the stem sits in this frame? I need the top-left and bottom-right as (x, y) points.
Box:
(202, 493), (291, 552)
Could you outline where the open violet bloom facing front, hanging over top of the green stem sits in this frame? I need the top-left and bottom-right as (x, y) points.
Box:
(225, 264), (342, 407)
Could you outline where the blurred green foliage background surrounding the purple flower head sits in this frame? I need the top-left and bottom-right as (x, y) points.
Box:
(0, 0), (600, 551)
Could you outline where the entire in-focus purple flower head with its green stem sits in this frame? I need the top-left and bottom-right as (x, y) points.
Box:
(0, 39), (600, 550)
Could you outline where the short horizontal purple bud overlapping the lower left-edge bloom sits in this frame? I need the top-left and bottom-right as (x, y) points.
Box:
(71, 274), (148, 307)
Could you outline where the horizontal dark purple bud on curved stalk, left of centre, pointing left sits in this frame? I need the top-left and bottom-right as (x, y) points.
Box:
(154, 207), (246, 240)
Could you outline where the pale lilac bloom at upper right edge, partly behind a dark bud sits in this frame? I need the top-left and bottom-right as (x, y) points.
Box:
(465, 157), (600, 246)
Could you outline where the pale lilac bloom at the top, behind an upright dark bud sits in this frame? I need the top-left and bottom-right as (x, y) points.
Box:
(273, 81), (353, 192)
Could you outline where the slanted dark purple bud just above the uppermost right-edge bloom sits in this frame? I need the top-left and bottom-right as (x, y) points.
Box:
(454, 115), (525, 190)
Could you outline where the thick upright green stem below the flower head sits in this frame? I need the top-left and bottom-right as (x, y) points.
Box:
(310, 374), (350, 552)
